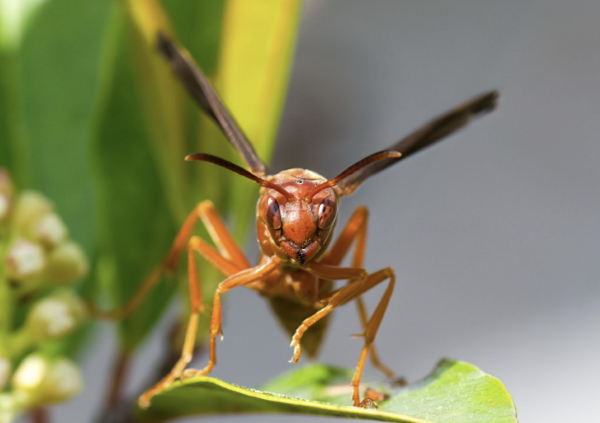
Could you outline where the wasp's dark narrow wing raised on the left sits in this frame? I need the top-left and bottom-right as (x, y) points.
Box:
(158, 33), (266, 176)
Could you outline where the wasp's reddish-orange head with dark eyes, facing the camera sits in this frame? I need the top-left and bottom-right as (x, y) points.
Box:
(258, 169), (338, 265)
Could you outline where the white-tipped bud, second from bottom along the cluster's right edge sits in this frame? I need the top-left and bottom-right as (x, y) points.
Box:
(25, 290), (86, 342)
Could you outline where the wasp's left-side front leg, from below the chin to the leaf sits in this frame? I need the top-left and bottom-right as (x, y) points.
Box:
(182, 256), (282, 378)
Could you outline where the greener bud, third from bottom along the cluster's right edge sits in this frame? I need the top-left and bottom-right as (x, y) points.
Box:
(43, 241), (88, 286)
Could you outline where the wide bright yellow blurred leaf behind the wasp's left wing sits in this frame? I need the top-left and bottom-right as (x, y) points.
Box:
(216, 0), (302, 239)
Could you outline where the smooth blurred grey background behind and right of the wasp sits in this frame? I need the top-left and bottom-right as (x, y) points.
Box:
(55, 0), (600, 423)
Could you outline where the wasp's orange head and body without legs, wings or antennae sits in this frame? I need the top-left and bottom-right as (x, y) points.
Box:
(249, 169), (339, 357)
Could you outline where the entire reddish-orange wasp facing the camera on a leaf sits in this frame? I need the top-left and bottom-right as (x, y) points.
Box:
(95, 34), (498, 408)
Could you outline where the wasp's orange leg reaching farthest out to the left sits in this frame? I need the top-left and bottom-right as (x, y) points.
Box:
(88, 201), (250, 320)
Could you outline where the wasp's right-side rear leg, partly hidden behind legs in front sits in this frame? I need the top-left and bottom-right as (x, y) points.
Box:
(323, 206), (394, 378)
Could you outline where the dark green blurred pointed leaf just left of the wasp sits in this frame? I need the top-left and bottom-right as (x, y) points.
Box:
(91, 6), (176, 350)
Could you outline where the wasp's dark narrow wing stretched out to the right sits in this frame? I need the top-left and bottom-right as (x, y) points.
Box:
(337, 91), (498, 195)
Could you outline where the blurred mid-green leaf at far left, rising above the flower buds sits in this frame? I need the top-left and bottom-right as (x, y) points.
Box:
(20, 0), (110, 256)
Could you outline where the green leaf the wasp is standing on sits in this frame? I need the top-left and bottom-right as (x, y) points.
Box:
(139, 360), (517, 423)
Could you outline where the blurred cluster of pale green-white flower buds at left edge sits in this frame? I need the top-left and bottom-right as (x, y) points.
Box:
(0, 169), (88, 423)
